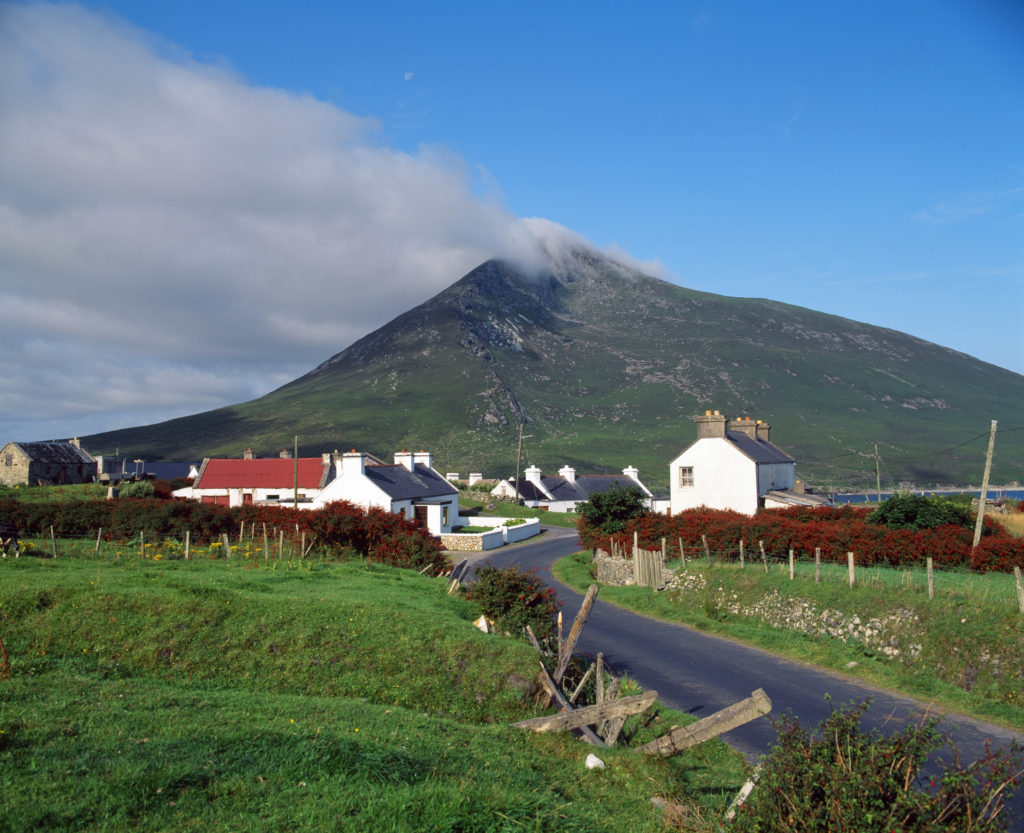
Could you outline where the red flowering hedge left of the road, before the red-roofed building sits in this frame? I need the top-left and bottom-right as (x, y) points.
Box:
(0, 498), (449, 572)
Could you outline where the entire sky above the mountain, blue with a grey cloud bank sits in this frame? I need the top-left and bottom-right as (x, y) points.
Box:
(0, 0), (1024, 440)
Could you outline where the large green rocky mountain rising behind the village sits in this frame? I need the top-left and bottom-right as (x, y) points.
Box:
(83, 248), (1024, 487)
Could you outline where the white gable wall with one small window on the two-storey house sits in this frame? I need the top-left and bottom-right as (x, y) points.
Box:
(669, 438), (759, 514)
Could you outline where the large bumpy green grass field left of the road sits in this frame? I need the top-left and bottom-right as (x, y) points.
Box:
(0, 556), (742, 831)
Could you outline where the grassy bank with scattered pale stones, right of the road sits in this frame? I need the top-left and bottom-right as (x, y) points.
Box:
(554, 552), (1024, 731)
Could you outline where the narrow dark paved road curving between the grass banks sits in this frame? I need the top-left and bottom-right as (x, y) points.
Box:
(468, 528), (1024, 833)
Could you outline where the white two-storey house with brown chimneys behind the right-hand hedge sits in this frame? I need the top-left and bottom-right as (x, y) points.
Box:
(669, 411), (828, 514)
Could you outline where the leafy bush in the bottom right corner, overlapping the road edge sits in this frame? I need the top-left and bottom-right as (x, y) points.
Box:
(731, 700), (1022, 833)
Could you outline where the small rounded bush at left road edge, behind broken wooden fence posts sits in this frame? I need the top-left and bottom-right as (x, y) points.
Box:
(466, 565), (560, 639)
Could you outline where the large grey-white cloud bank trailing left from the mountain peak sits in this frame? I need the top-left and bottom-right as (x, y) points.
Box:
(0, 4), (593, 440)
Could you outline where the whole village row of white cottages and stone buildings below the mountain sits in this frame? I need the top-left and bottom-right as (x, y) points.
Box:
(0, 410), (830, 550)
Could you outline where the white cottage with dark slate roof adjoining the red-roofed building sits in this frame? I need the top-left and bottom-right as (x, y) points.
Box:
(311, 450), (459, 535)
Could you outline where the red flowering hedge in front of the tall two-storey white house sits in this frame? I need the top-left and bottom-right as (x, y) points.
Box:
(577, 505), (1024, 572)
